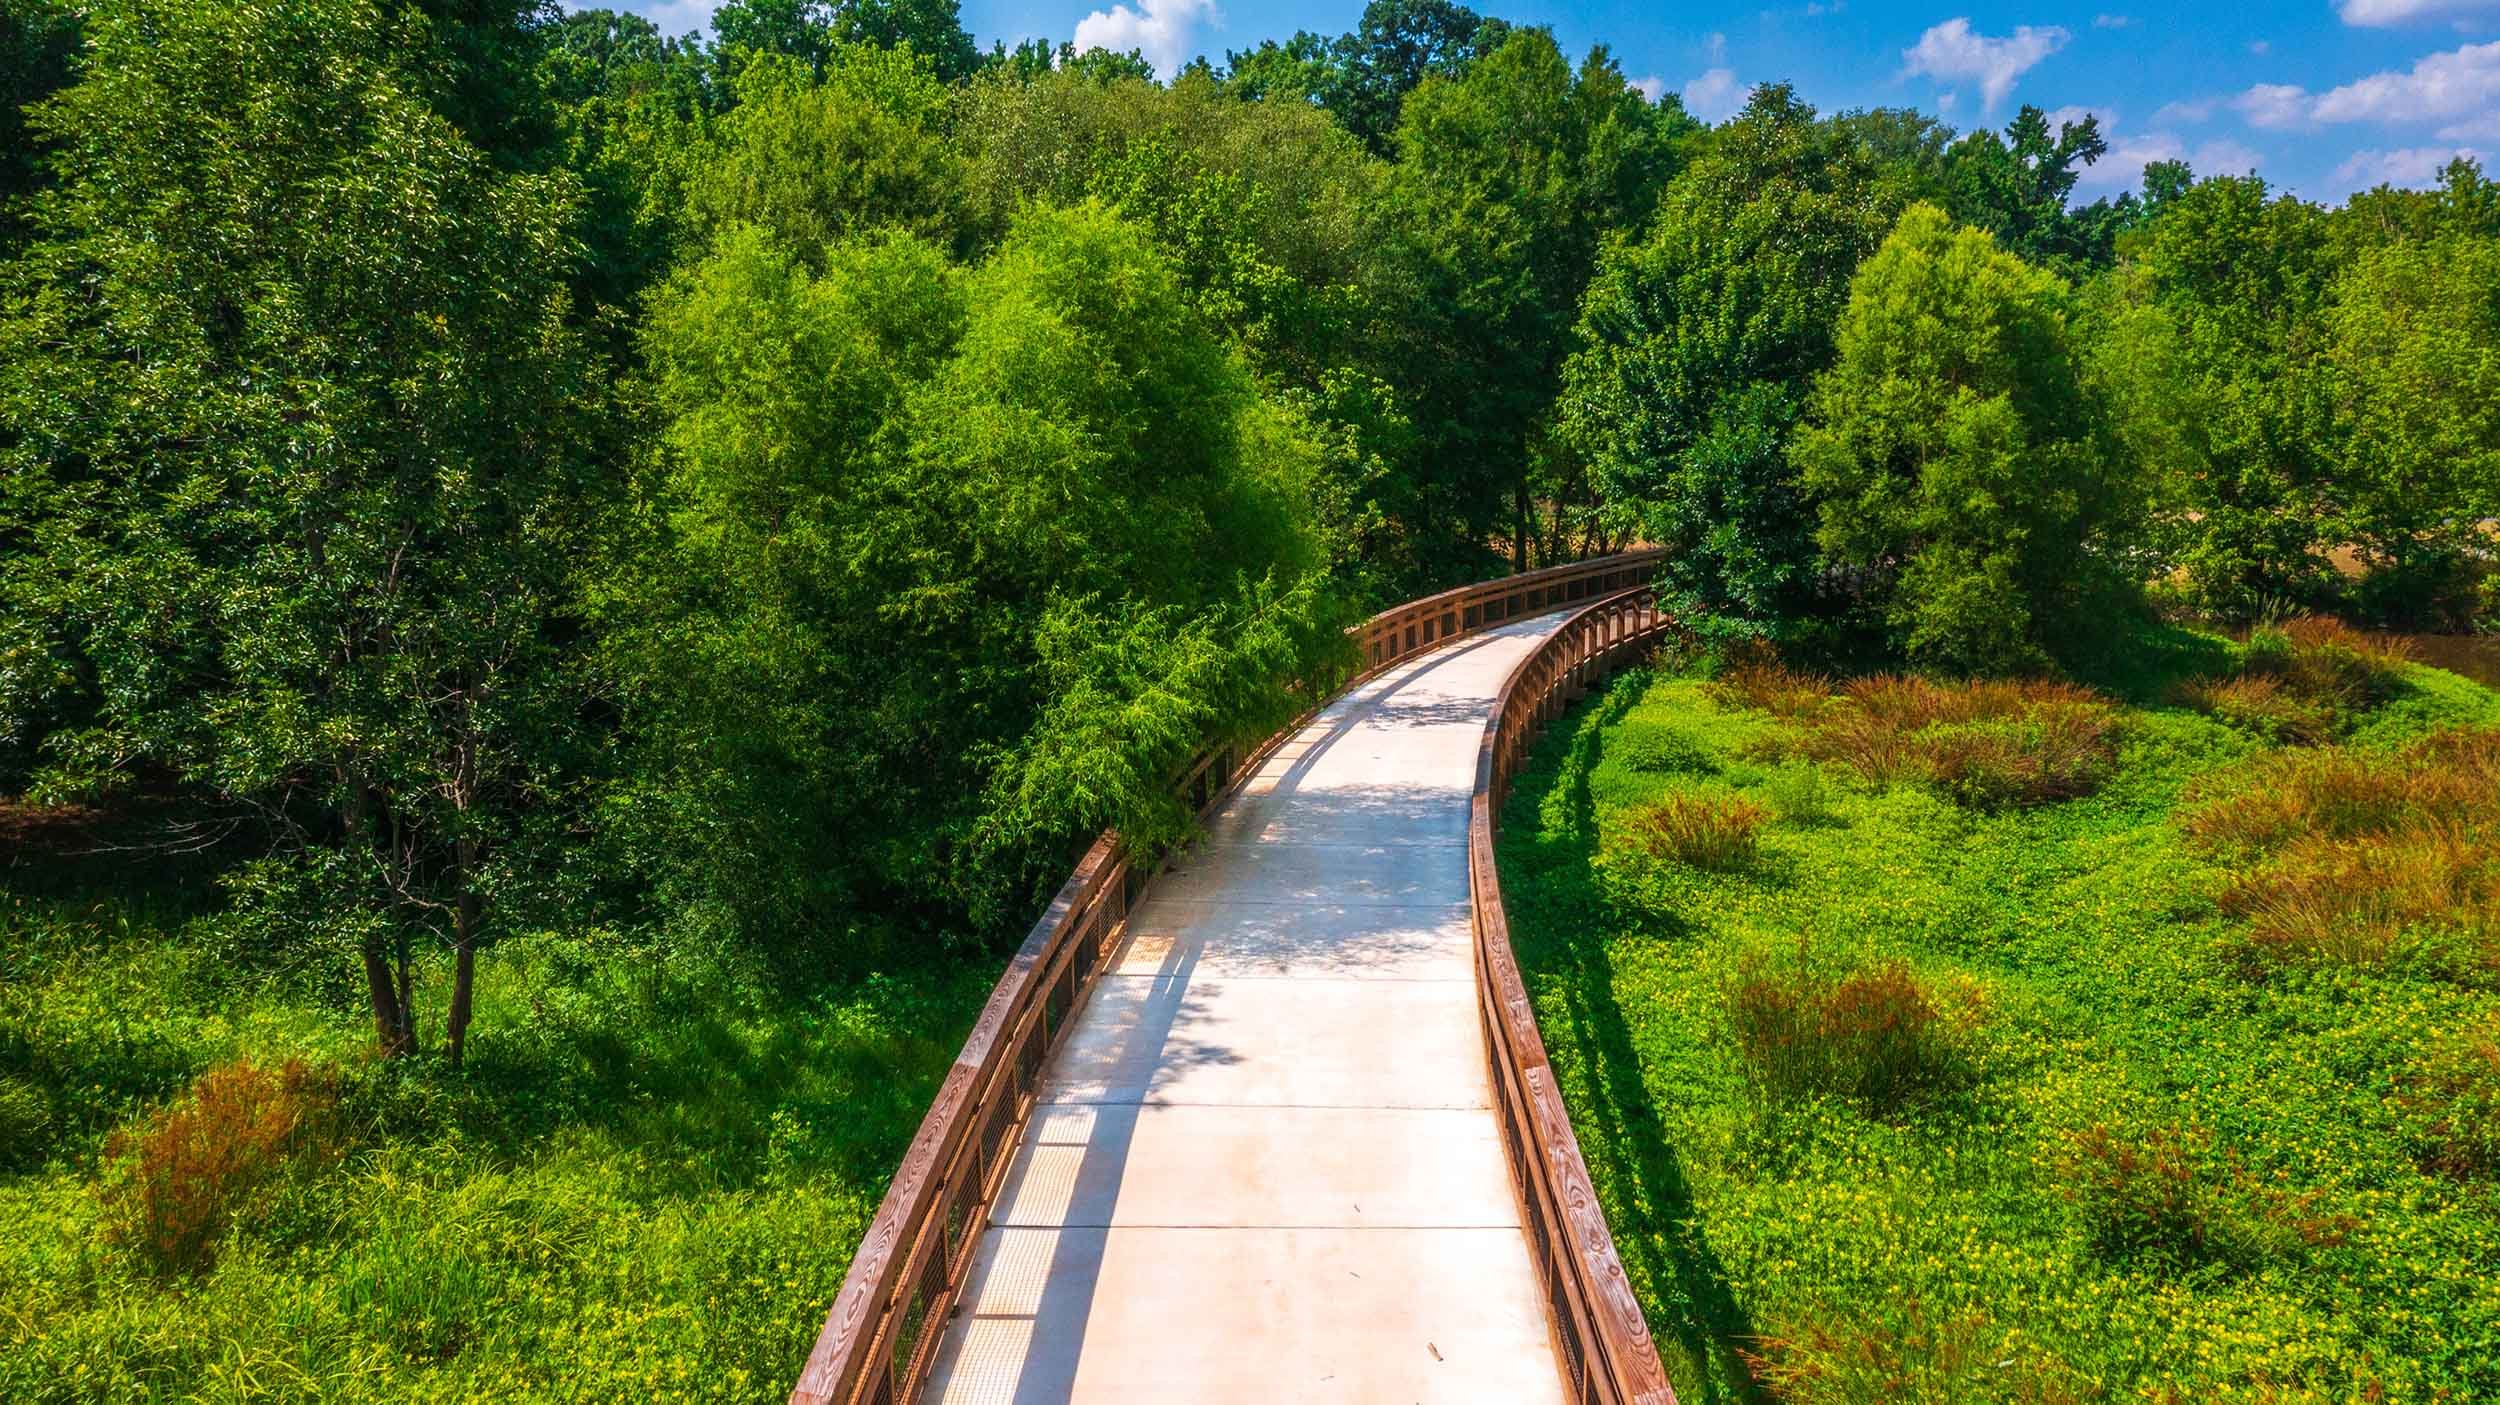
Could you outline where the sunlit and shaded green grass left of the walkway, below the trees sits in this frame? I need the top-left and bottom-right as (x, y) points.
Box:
(0, 835), (990, 1400)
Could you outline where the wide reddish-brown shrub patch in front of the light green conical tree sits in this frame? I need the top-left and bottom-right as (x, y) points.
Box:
(1795, 675), (2118, 810)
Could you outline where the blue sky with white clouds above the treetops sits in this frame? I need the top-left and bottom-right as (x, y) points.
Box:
(610, 0), (2500, 203)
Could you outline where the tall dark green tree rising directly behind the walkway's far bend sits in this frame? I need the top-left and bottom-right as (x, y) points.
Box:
(1398, 30), (1685, 570)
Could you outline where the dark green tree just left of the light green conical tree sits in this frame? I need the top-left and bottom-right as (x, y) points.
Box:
(1560, 85), (1915, 635)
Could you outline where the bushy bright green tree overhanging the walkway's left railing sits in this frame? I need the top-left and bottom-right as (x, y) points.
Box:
(603, 205), (1328, 950)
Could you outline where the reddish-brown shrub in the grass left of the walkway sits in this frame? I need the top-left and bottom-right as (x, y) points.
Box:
(103, 1060), (338, 1273)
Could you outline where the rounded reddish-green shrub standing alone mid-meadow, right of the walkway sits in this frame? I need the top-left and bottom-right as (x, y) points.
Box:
(1728, 950), (1958, 1110)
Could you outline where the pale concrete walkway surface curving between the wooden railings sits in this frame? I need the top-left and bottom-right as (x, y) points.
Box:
(925, 615), (1563, 1405)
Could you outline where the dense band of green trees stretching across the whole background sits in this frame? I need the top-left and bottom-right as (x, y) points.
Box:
(0, 0), (2500, 1058)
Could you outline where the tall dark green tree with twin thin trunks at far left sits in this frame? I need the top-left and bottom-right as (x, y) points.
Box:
(0, 0), (600, 1060)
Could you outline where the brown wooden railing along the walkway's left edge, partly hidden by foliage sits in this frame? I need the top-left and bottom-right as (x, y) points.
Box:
(790, 553), (1670, 1405)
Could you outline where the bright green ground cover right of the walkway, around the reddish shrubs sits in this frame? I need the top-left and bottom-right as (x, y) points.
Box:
(1500, 640), (2500, 1403)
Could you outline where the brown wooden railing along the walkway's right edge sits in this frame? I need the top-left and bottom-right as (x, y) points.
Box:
(1468, 585), (1675, 1405)
